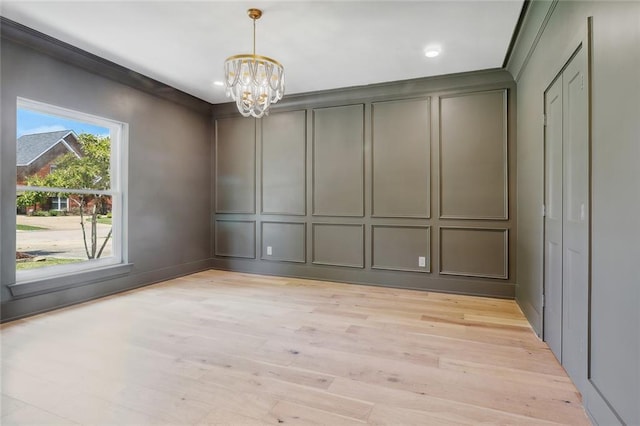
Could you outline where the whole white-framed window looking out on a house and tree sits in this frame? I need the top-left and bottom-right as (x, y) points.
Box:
(12, 98), (127, 294)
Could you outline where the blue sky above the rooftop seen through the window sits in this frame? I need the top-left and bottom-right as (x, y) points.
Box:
(17, 108), (109, 137)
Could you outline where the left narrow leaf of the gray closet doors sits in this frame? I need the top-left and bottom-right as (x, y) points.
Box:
(544, 76), (563, 361)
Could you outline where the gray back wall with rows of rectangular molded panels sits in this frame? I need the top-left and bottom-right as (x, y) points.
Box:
(213, 71), (516, 297)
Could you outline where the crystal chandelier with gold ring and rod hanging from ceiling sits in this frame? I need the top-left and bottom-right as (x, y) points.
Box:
(224, 9), (284, 118)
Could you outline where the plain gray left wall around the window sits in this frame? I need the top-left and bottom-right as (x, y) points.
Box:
(0, 25), (212, 320)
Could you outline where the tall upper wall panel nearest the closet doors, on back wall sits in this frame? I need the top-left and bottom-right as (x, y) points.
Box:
(438, 89), (509, 220)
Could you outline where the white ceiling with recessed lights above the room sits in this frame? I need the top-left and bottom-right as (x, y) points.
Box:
(0, 0), (523, 103)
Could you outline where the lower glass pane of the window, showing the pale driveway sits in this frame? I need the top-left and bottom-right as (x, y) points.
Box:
(16, 191), (113, 270)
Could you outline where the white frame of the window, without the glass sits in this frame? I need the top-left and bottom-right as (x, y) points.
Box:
(9, 97), (132, 296)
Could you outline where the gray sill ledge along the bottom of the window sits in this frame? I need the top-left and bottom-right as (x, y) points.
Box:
(9, 263), (133, 297)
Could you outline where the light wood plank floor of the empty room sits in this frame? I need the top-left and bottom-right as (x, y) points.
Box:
(0, 271), (589, 425)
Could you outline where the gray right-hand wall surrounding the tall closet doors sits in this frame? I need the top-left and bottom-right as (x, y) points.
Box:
(508, 1), (640, 424)
